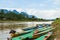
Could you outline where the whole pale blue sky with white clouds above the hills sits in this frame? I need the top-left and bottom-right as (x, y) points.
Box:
(0, 0), (60, 19)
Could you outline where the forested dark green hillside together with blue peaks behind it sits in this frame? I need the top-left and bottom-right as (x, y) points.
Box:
(0, 9), (38, 20)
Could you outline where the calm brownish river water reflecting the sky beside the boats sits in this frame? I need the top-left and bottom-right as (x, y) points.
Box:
(0, 21), (53, 40)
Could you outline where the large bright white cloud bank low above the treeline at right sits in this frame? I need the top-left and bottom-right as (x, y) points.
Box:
(27, 9), (60, 19)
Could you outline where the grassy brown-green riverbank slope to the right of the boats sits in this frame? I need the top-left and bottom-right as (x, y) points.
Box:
(48, 18), (60, 40)
